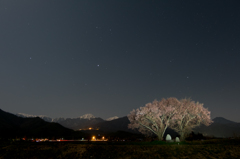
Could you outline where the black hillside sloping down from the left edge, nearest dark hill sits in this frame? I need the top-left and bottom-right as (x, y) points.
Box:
(0, 109), (83, 138)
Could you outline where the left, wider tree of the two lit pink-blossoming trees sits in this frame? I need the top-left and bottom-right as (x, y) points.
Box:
(128, 97), (181, 140)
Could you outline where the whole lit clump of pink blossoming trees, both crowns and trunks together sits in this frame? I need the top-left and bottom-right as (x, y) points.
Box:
(128, 97), (212, 140)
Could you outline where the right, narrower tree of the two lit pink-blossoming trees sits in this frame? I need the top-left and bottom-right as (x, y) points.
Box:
(169, 99), (213, 141)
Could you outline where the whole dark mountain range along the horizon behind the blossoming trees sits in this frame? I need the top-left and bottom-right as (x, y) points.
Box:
(0, 109), (240, 138)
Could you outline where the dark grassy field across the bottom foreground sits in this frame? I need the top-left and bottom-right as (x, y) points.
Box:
(0, 139), (240, 159)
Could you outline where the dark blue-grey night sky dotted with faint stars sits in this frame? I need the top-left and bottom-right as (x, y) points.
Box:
(0, 0), (240, 122)
